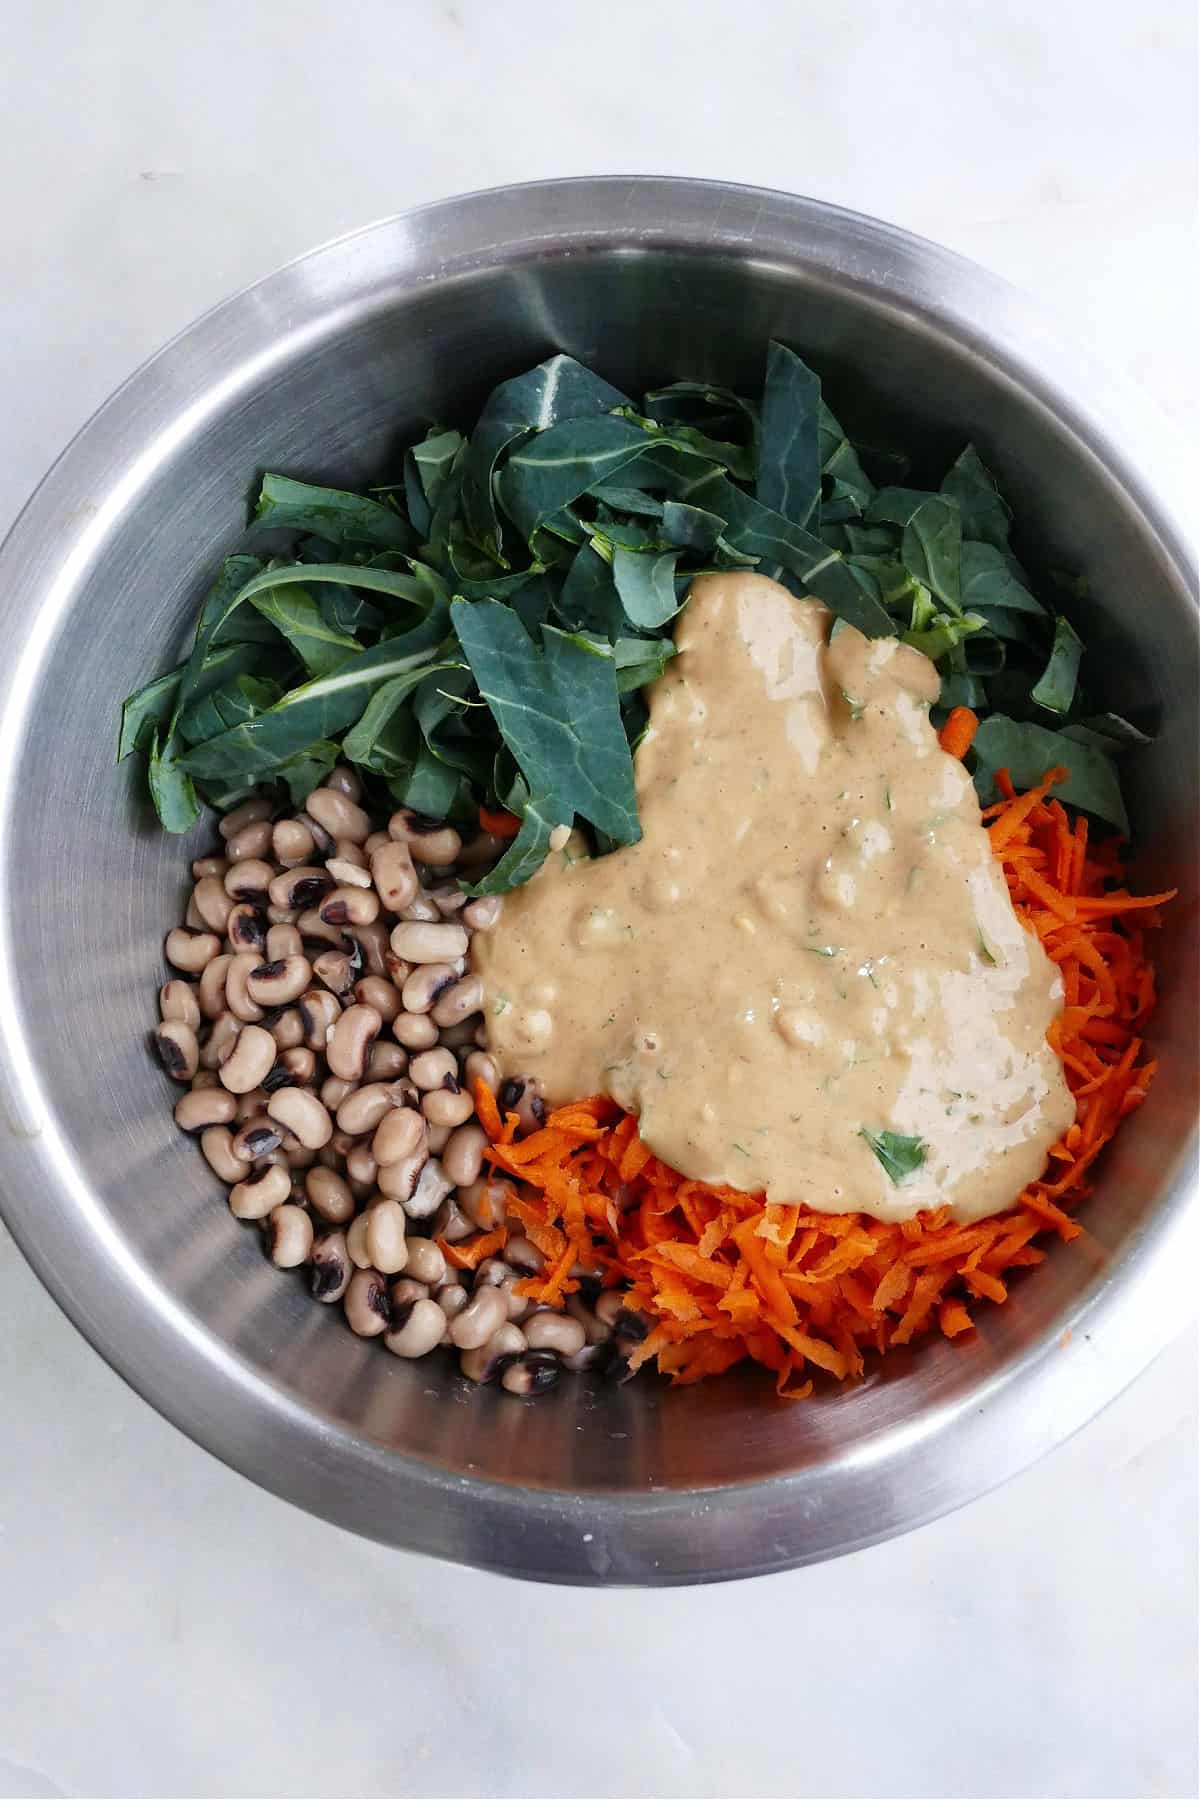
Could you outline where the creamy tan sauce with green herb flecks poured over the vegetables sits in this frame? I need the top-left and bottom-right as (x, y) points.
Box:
(473, 574), (1074, 1219)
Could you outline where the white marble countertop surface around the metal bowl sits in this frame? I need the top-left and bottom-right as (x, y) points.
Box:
(0, 0), (1200, 1796)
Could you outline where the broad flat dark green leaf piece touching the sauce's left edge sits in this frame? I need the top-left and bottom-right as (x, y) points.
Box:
(452, 594), (640, 844)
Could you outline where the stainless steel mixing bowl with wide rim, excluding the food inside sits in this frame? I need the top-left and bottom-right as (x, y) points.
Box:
(0, 180), (1198, 1582)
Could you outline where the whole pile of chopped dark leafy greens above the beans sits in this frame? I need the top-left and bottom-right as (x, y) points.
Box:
(119, 342), (1144, 885)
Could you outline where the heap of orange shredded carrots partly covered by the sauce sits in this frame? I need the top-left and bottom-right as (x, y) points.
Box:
(471, 770), (1173, 1399)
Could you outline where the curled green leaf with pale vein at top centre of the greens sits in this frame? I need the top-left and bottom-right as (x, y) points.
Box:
(462, 355), (630, 558)
